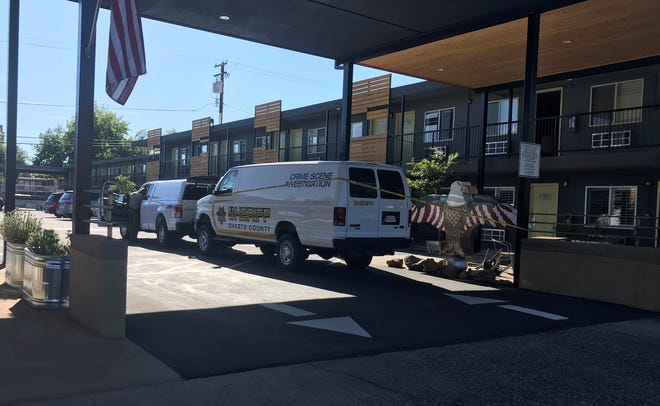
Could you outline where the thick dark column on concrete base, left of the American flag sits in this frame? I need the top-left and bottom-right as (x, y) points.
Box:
(73, 0), (96, 234)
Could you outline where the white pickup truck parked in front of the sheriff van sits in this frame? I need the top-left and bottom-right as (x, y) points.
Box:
(119, 176), (220, 246)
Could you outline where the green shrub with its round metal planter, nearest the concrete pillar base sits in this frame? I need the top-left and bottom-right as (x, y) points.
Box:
(23, 229), (71, 308)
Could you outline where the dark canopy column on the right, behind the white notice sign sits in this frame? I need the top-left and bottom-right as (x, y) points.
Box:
(513, 13), (540, 286)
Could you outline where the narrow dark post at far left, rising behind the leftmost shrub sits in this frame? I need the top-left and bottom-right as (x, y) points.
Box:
(4, 0), (20, 213)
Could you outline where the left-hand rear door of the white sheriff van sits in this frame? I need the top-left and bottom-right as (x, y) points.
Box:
(346, 167), (380, 238)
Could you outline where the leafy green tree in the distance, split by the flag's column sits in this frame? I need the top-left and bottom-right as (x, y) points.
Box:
(33, 106), (143, 166)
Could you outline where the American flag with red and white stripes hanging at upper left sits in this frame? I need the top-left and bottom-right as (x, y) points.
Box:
(105, 0), (147, 105)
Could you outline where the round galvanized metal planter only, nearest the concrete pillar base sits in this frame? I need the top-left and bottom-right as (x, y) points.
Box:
(23, 248), (71, 308)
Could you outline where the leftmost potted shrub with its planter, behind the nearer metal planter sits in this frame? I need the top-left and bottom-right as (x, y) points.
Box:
(0, 210), (41, 287)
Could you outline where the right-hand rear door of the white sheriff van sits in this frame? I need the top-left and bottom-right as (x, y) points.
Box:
(376, 168), (408, 238)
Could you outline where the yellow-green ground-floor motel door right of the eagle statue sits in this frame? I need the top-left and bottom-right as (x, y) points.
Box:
(529, 183), (559, 238)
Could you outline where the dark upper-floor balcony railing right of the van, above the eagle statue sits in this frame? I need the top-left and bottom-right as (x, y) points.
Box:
(388, 105), (660, 165)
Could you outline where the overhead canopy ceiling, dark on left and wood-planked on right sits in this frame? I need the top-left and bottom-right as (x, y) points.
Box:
(78, 0), (660, 88)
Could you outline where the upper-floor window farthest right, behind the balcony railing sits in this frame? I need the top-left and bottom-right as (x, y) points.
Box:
(590, 79), (644, 127)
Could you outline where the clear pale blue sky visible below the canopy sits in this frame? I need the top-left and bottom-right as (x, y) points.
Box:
(0, 0), (419, 162)
